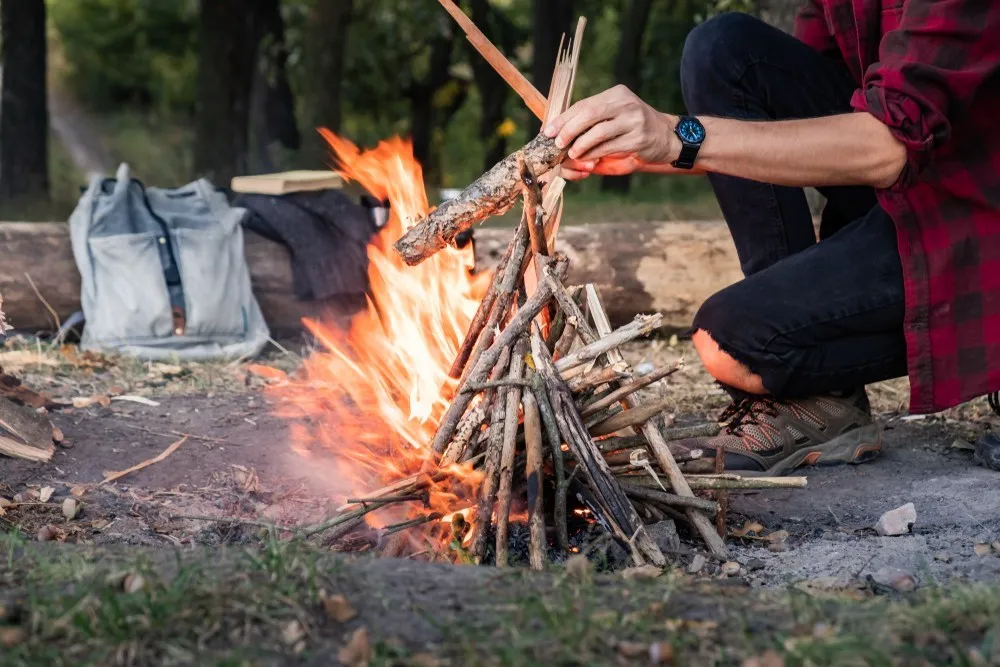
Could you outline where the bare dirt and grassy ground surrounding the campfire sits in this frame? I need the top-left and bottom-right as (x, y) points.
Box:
(0, 340), (1000, 665)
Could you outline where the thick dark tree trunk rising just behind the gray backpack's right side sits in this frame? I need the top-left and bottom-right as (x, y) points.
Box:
(194, 0), (269, 187)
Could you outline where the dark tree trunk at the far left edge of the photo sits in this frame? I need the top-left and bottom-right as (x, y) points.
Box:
(0, 0), (49, 205)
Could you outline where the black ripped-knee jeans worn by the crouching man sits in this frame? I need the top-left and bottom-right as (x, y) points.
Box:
(681, 13), (906, 397)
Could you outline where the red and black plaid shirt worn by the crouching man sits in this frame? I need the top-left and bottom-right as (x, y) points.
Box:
(795, 0), (1000, 413)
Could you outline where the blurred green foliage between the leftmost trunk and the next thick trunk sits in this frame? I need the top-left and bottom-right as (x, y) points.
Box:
(49, 0), (197, 110)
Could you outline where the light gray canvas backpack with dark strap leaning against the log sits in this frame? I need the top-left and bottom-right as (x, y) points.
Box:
(69, 164), (270, 361)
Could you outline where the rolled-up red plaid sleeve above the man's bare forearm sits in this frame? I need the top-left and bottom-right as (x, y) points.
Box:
(851, 0), (1000, 190)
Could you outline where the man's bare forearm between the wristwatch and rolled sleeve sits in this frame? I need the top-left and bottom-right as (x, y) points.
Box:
(650, 113), (906, 188)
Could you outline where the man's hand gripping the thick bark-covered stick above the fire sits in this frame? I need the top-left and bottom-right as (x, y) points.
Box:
(543, 86), (681, 180)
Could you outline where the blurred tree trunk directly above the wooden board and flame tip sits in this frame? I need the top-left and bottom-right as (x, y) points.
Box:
(302, 0), (354, 167)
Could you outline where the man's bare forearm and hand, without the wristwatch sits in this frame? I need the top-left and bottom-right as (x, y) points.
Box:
(545, 86), (906, 187)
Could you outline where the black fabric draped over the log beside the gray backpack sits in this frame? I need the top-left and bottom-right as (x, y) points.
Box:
(232, 190), (378, 300)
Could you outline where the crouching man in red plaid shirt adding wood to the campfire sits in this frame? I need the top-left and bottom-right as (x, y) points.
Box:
(544, 0), (1000, 474)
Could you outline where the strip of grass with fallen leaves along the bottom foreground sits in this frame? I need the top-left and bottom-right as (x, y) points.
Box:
(0, 535), (1000, 666)
